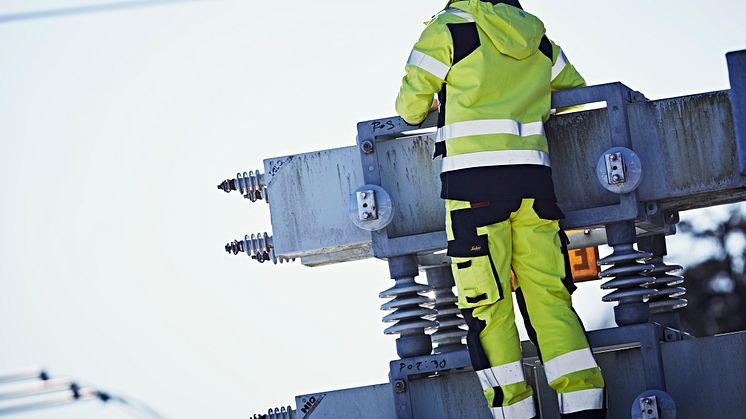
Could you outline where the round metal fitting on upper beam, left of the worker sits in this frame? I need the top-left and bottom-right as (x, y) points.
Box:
(347, 185), (394, 231)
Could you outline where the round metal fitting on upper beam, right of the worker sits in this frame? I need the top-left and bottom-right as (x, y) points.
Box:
(596, 147), (642, 194)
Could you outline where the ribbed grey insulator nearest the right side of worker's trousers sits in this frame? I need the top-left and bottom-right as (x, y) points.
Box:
(598, 243), (658, 326)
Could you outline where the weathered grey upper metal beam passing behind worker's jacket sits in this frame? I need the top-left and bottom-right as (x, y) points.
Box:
(264, 92), (746, 265)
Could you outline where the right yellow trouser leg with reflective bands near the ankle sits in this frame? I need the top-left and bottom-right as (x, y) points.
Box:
(510, 199), (604, 413)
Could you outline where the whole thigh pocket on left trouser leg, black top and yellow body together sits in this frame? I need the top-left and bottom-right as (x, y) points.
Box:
(448, 235), (503, 308)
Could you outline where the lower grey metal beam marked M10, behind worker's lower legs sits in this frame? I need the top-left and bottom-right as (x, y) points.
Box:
(296, 332), (746, 419)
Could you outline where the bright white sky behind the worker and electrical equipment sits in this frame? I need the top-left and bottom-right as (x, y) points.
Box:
(0, 0), (746, 418)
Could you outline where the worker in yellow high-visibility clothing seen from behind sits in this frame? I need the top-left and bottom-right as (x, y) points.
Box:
(396, 0), (605, 419)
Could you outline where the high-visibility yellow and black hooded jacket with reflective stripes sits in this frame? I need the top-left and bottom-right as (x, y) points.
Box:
(396, 0), (585, 200)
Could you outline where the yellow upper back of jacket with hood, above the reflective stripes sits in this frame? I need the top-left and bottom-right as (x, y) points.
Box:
(431, 2), (552, 130)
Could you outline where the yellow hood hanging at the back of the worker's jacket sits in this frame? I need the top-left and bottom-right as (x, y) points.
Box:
(448, 0), (545, 60)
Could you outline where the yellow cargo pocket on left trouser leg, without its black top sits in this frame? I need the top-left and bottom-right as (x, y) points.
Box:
(451, 253), (503, 309)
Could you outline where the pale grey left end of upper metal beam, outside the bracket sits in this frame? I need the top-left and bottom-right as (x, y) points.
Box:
(264, 147), (371, 264)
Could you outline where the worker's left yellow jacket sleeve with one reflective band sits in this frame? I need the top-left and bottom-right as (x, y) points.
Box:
(396, 19), (453, 125)
